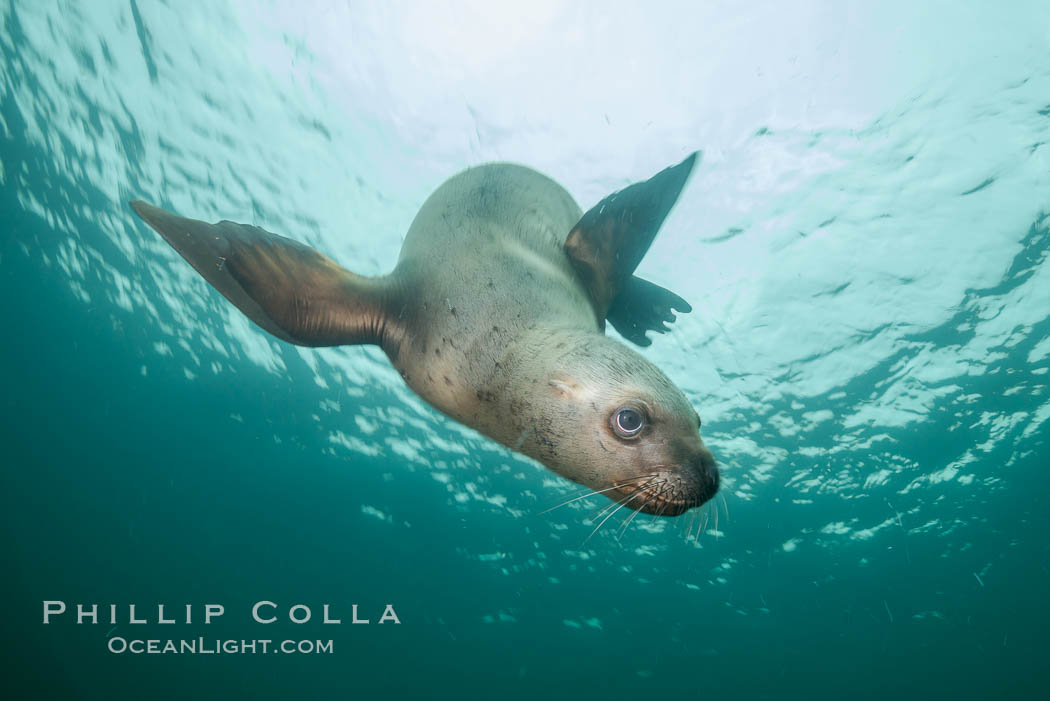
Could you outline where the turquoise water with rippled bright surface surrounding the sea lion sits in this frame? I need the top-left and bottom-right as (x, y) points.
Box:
(6, 0), (1050, 699)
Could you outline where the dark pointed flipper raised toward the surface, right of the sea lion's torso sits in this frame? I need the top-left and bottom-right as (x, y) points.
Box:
(565, 151), (698, 319)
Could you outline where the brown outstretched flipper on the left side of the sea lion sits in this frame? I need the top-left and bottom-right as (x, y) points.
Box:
(131, 200), (389, 346)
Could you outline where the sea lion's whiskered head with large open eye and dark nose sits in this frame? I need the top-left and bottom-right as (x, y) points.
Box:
(510, 331), (720, 516)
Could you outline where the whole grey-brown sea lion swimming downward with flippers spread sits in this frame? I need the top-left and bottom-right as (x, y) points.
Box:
(131, 153), (719, 515)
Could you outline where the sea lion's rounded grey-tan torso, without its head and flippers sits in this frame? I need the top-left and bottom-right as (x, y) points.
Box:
(390, 164), (597, 432)
